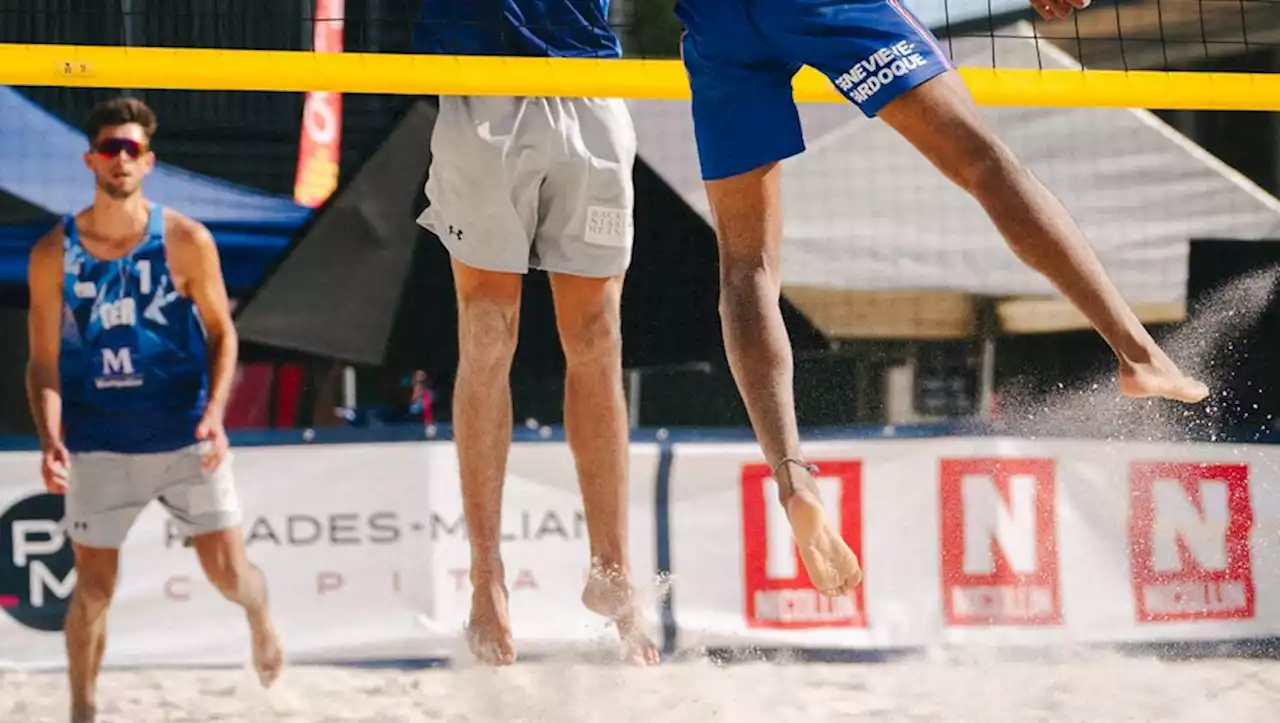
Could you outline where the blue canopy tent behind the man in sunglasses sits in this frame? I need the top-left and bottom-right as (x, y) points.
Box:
(0, 86), (311, 289)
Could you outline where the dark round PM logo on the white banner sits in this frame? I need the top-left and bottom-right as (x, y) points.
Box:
(0, 494), (76, 632)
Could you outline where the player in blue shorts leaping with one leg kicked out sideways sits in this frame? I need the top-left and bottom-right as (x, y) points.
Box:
(676, 0), (1208, 595)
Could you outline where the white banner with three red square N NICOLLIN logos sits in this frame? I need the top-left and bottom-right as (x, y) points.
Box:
(671, 438), (1280, 649)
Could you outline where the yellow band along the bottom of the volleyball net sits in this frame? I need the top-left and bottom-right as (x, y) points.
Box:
(0, 44), (1280, 110)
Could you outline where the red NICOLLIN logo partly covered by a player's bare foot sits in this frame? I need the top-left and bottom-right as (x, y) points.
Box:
(742, 461), (867, 628)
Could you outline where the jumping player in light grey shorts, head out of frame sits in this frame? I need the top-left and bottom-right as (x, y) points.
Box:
(413, 0), (658, 665)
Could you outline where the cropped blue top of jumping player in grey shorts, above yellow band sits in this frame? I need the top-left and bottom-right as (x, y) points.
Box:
(413, 0), (622, 58)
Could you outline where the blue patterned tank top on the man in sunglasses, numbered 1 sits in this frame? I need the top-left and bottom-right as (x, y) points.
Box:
(59, 205), (209, 454)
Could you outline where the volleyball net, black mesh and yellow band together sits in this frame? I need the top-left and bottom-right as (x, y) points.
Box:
(0, 0), (1280, 110)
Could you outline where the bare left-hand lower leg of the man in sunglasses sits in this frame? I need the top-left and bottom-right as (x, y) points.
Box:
(65, 543), (120, 723)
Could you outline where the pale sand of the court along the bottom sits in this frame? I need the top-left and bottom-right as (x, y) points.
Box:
(0, 654), (1280, 723)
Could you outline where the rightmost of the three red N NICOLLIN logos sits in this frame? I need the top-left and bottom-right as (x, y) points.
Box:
(1129, 462), (1253, 622)
